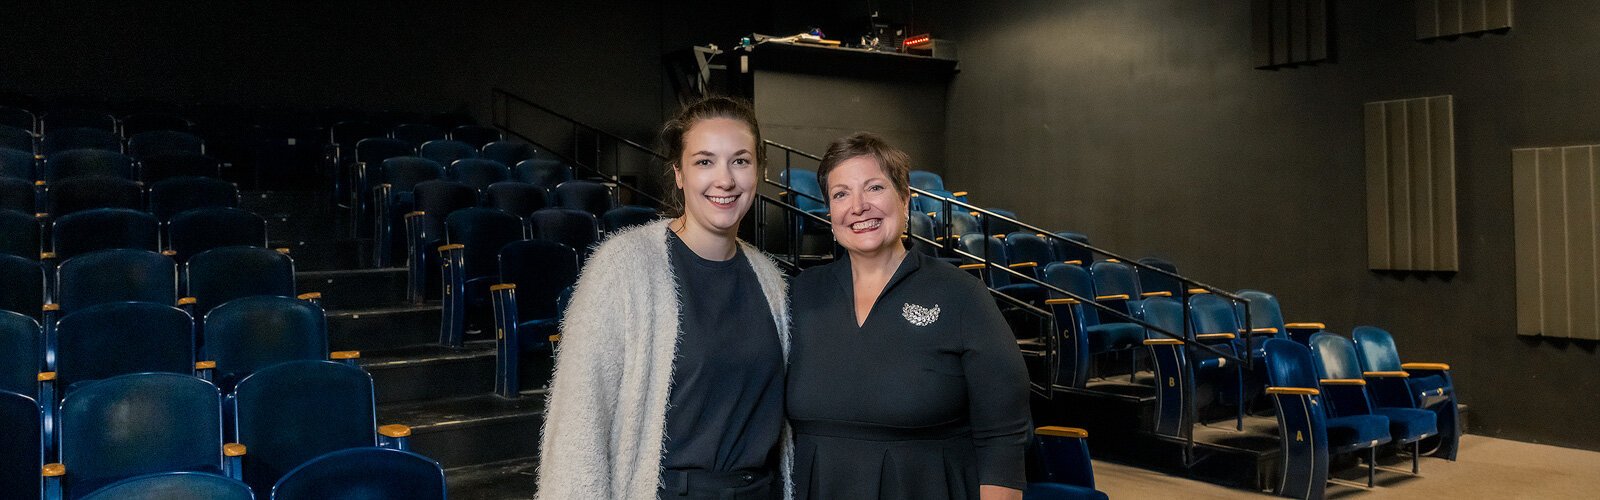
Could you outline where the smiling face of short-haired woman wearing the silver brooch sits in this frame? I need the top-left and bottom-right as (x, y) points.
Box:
(827, 155), (910, 253)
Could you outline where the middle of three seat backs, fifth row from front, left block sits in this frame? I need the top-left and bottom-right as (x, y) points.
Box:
(51, 208), (162, 260)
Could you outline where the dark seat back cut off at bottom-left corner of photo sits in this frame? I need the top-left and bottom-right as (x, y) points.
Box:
(0, 389), (45, 498)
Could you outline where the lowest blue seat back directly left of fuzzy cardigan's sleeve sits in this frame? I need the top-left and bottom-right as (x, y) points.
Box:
(499, 239), (578, 321)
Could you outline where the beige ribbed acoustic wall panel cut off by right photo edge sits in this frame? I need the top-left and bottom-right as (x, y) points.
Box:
(1512, 146), (1600, 340)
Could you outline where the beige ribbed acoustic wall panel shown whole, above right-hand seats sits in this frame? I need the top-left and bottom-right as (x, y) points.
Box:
(1363, 96), (1458, 271)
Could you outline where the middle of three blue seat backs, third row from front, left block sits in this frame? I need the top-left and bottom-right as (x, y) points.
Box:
(56, 301), (195, 391)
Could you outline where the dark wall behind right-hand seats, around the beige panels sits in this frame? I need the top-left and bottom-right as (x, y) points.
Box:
(938, 0), (1600, 449)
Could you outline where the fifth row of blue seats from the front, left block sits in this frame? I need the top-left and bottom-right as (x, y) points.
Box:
(0, 207), (267, 263)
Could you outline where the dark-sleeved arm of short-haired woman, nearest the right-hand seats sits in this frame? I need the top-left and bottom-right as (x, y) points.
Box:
(962, 287), (1029, 500)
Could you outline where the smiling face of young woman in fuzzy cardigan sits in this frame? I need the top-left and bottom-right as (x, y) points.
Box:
(674, 119), (758, 237)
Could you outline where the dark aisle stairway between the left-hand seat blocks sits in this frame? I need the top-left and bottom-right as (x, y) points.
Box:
(243, 191), (544, 498)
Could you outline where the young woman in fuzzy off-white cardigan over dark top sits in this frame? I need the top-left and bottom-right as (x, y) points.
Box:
(539, 98), (792, 500)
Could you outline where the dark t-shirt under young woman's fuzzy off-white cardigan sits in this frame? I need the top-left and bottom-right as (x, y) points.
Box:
(661, 231), (784, 471)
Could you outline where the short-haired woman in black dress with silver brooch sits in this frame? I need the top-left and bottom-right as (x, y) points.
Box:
(786, 133), (1029, 500)
